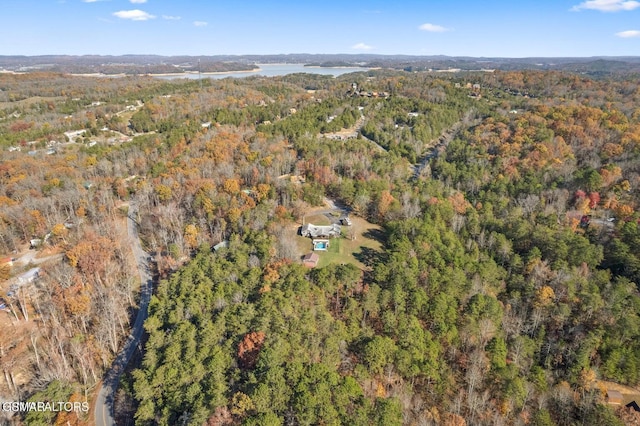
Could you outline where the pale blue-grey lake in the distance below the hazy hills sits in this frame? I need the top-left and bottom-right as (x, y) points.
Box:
(158, 64), (370, 80)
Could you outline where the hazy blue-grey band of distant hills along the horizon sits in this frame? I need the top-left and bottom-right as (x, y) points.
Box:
(0, 53), (640, 76)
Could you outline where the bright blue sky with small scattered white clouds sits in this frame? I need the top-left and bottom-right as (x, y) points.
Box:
(0, 0), (640, 58)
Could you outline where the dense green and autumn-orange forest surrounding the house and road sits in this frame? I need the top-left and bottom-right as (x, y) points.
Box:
(0, 66), (640, 426)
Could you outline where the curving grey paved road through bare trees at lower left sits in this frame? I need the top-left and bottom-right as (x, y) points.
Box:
(94, 201), (153, 426)
